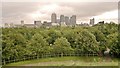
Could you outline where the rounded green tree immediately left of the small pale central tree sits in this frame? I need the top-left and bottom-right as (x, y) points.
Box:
(28, 34), (48, 55)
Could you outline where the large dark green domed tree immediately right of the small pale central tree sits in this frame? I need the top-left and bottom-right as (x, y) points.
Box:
(75, 30), (99, 53)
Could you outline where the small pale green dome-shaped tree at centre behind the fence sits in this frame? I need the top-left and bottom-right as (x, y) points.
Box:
(53, 37), (73, 54)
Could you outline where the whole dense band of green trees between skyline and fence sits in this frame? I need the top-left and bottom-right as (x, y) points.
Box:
(1, 23), (120, 59)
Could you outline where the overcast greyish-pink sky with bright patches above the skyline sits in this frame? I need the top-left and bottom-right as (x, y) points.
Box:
(0, 0), (118, 24)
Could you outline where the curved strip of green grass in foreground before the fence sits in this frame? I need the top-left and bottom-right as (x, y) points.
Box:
(5, 57), (119, 66)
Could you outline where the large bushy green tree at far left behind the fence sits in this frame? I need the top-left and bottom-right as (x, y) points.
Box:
(2, 33), (26, 59)
